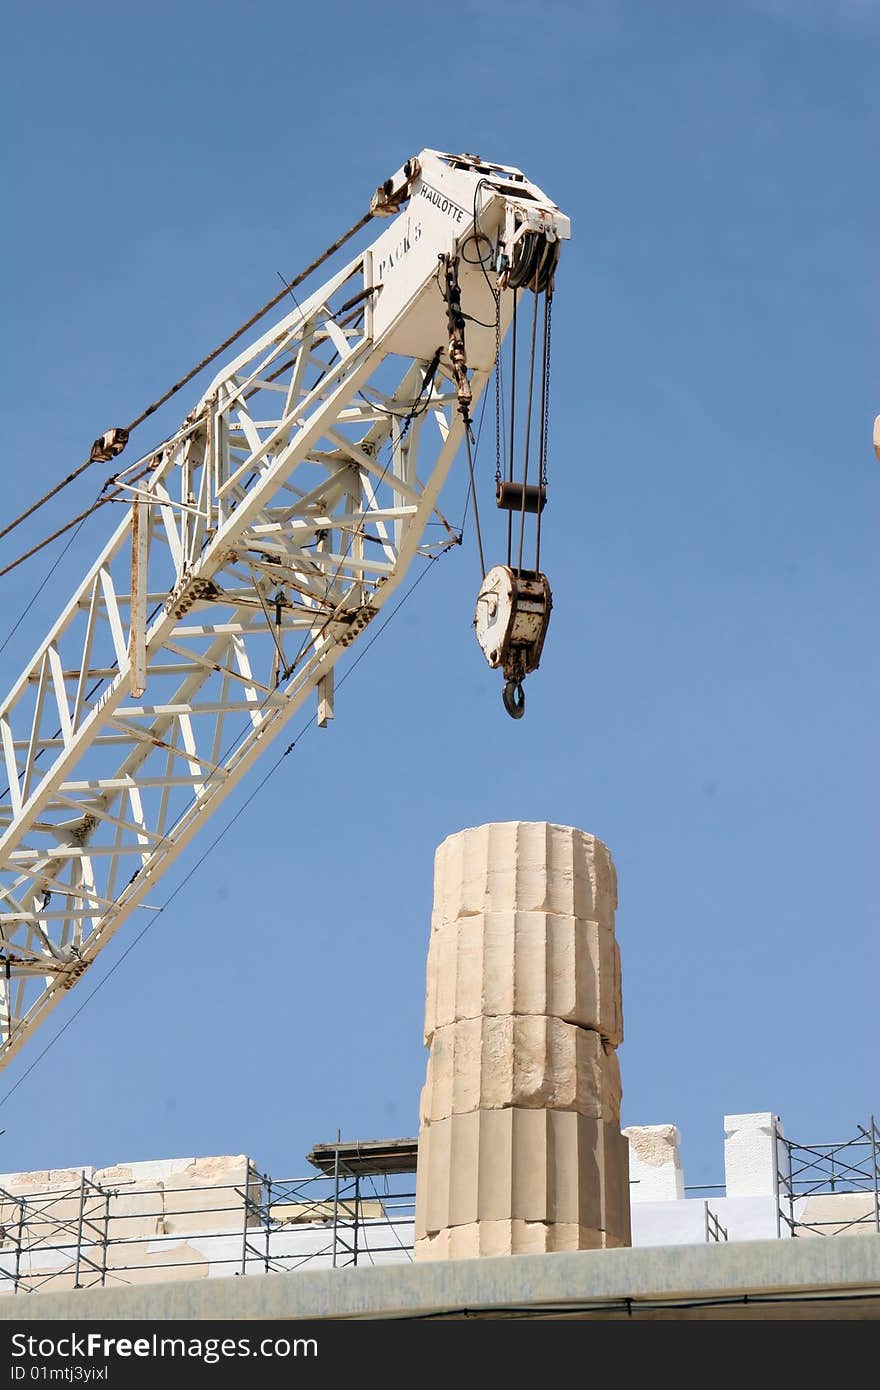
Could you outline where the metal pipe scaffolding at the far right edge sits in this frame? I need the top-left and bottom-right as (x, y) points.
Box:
(776, 1115), (880, 1236)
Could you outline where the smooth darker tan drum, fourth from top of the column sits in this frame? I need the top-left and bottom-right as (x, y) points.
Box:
(416, 1108), (630, 1244)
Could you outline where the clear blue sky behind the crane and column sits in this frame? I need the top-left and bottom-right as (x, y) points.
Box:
(0, 0), (880, 1183)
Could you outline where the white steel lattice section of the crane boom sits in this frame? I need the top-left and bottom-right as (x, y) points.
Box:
(0, 255), (481, 1052)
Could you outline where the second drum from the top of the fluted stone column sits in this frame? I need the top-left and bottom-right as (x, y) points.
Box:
(425, 912), (623, 1047)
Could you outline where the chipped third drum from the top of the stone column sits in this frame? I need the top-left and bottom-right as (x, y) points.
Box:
(420, 1015), (620, 1123)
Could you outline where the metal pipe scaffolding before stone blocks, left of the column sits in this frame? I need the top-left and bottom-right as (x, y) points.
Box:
(0, 1141), (416, 1294)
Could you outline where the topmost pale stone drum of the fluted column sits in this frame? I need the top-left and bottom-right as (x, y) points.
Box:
(432, 820), (617, 927)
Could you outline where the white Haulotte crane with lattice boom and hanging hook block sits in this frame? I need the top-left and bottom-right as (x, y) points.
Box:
(0, 150), (570, 1066)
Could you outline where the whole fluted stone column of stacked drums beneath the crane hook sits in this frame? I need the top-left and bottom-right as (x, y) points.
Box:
(416, 821), (630, 1259)
